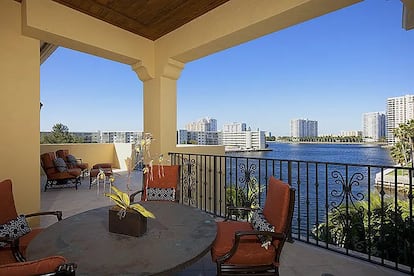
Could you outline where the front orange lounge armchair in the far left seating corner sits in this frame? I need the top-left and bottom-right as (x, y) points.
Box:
(40, 152), (81, 191)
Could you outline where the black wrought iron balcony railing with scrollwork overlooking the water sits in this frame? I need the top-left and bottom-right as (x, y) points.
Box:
(170, 153), (414, 274)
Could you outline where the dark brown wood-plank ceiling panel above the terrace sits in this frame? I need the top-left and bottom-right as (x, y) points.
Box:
(53, 0), (229, 40)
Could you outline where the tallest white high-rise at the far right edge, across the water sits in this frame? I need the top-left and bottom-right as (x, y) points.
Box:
(386, 95), (414, 144)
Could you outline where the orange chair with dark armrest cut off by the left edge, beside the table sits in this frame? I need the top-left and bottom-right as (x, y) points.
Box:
(0, 179), (62, 264)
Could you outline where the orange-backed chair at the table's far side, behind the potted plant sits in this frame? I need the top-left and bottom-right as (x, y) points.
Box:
(130, 165), (180, 202)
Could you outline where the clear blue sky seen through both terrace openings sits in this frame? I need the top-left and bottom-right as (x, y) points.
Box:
(40, 0), (414, 136)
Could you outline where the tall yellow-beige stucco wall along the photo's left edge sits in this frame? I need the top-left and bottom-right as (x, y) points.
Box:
(0, 0), (40, 216)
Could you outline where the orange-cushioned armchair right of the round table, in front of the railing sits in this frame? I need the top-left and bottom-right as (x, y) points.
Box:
(211, 176), (295, 275)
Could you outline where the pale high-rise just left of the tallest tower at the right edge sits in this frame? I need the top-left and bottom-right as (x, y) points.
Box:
(362, 112), (385, 142)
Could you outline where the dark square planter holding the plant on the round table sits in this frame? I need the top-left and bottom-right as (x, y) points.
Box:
(108, 206), (147, 237)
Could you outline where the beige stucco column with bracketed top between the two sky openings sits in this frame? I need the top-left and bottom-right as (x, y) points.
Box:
(132, 59), (184, 161)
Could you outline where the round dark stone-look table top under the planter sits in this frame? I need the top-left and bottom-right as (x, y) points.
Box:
(26, 201), (217, 275)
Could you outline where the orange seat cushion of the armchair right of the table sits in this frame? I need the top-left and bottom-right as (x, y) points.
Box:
(211, 221), (275, 265)
